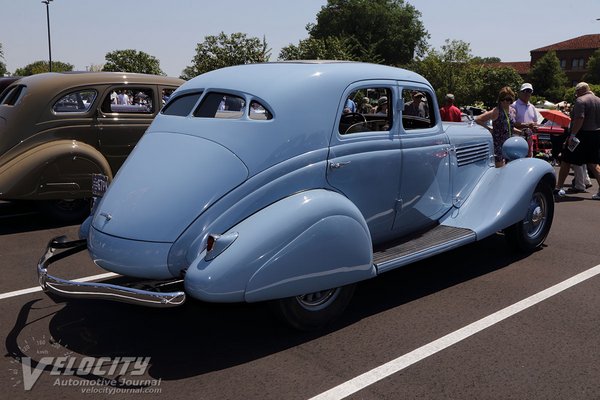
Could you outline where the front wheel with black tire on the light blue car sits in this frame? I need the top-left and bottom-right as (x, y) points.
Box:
(504, 182), (554, 253)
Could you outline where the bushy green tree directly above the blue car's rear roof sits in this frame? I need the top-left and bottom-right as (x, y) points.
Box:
(181, 32), (271, 79)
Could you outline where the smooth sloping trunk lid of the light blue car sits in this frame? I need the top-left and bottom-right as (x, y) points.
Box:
(92, 132), (248, 242)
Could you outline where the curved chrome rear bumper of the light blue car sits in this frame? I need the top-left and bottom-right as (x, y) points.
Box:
(37, 236), (186, 308)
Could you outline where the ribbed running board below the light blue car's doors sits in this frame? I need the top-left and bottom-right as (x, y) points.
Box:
(373, 225), (477, 273)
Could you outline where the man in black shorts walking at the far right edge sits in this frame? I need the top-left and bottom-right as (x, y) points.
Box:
(555, 82), (600, 200)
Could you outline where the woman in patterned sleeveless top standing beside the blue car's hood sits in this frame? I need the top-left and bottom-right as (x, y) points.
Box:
(475, 86), (521, 168)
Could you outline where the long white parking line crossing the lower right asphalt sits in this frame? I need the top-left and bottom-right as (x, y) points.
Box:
(310, 265), (600, 400)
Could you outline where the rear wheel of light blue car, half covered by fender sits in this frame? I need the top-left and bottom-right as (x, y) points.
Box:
(271, 284), (356, 331)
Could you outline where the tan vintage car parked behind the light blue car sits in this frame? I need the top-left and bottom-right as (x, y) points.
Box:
(0, 72), (184, 221)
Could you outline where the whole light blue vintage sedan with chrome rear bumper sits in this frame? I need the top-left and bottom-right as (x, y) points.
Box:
(38, 61), (555, 329)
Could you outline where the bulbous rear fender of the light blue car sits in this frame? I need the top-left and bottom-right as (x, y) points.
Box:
(185, 189), (376, 302)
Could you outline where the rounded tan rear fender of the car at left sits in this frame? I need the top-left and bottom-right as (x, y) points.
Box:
(0, 140), (112, 200)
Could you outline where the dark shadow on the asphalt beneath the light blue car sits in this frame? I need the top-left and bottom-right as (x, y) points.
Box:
(6, 235), (536, 380)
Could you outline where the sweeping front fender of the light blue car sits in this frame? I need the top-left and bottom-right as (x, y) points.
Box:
(440, 158), (556, 240)
